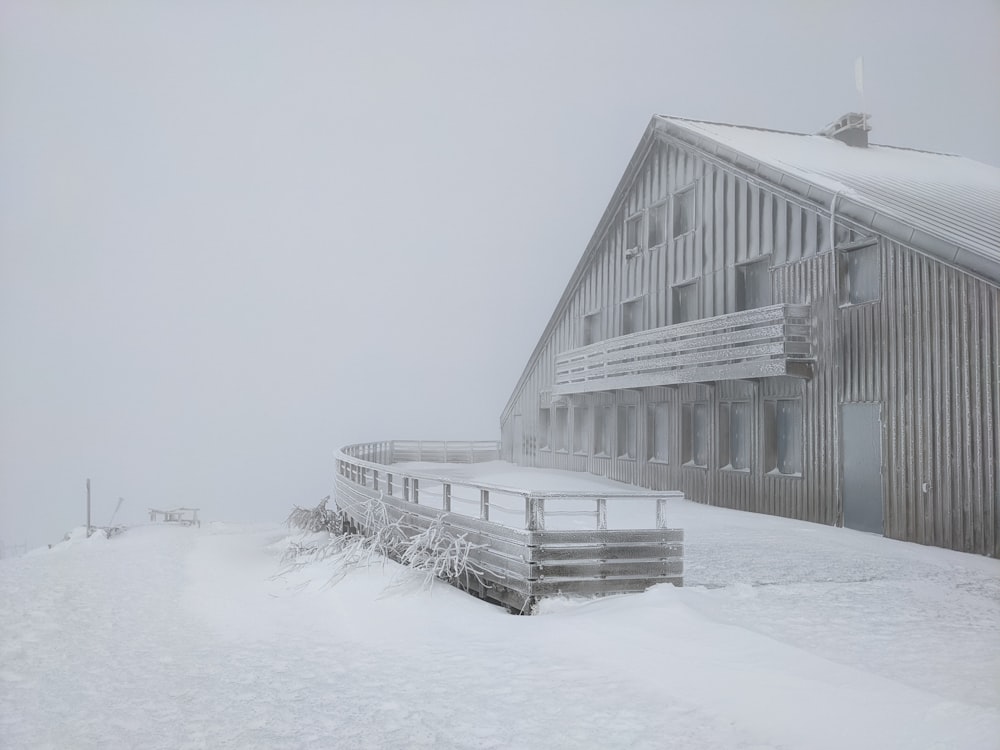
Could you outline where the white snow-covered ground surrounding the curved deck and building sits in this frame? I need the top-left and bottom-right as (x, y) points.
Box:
(0, 467), (1000, 750)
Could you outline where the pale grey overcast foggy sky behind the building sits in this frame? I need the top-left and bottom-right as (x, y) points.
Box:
(0, 0), (1000, 547)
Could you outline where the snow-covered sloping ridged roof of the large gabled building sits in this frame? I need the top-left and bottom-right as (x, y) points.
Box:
(654, 116), (1000, 283)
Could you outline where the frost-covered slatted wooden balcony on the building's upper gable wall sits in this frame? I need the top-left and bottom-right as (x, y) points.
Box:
(552, 305), (813, 395)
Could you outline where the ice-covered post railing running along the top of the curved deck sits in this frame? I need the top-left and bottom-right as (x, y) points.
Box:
(337, 441), (684, 531)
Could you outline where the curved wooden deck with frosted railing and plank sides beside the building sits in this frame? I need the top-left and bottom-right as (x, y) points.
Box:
(335, 441), (684, 612)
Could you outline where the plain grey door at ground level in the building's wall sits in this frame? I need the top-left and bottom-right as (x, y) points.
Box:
(840, 403), (883, 534)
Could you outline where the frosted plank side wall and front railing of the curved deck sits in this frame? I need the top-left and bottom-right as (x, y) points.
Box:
(335, 442), (683, 611)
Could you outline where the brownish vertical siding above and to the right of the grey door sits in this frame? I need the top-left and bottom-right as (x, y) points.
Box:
(839, 240), (1000, 557)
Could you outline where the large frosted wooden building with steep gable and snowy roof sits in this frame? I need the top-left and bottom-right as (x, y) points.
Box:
(501, 113), (1000, 557)
